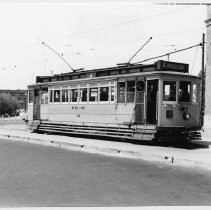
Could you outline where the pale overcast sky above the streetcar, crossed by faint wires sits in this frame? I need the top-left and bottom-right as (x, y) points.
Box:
(0, 2), (207, 89)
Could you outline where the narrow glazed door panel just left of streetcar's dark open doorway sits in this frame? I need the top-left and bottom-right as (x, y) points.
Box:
(134, 80), (145, 124)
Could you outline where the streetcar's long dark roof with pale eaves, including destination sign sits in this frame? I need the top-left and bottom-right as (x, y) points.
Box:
(28, 60), (200, 87)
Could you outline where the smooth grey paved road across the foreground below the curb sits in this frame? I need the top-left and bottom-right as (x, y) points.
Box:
(0, 140), (211, 207)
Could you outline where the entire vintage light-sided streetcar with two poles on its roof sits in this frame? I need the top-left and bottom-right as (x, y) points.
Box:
(28, 60), (202, 141)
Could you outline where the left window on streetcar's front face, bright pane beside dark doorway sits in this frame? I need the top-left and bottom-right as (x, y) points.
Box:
(163, 81), (176, 101)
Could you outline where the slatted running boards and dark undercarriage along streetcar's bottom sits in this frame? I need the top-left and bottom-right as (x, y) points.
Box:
(31, 121), (201, 141)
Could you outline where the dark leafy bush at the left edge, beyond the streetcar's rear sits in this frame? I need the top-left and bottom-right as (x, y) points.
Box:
(0, 94), (20, 115)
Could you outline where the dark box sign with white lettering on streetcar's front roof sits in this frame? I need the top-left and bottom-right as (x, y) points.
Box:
(157, 60), (189, 73)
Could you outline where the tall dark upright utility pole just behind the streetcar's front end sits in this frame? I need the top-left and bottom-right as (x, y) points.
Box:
(201, 33), (206, 126)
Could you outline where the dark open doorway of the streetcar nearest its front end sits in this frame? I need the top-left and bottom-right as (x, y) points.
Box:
(146, 79), (158, 124)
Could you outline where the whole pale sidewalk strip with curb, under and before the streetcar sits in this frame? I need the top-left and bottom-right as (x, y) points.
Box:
(0, 125), (211, 170)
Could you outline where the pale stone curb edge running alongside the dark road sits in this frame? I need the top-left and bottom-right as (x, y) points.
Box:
(0, 134), (211, 170)
